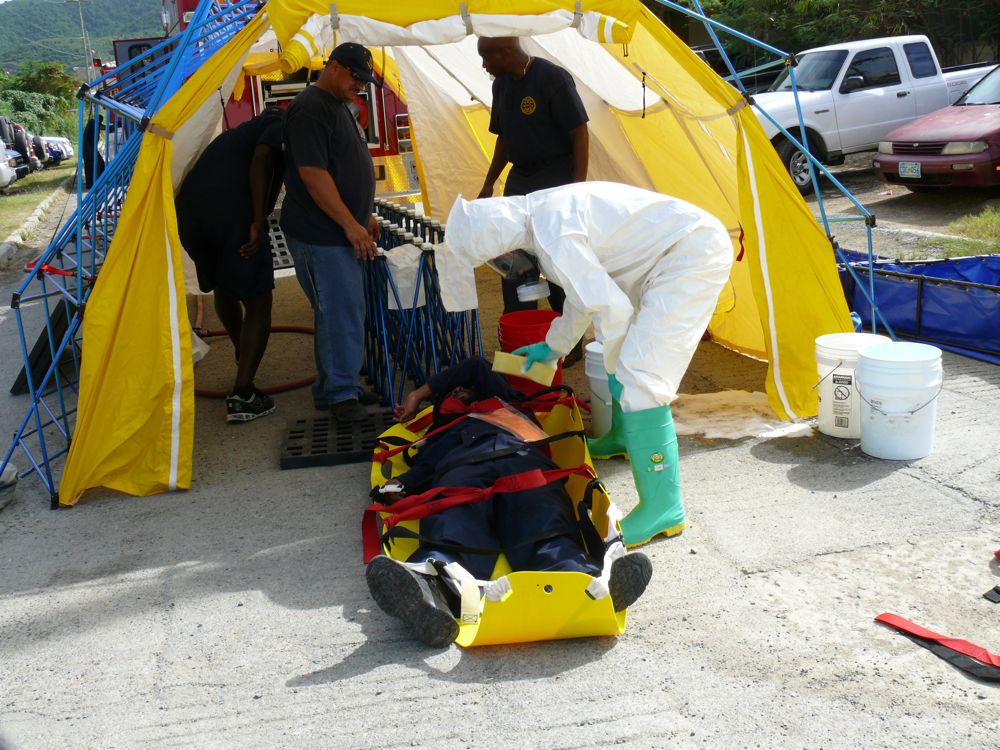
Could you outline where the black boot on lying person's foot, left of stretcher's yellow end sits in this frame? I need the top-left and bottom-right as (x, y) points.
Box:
(365, 555), (458, 648)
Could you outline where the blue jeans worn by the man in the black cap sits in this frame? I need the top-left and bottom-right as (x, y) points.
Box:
(285, 235), (365, 408)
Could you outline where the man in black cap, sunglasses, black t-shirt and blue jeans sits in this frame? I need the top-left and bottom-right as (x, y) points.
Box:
(281, 42), (378, 422)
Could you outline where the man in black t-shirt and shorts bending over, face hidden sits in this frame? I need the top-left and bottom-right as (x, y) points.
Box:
(176, 107), (284, 422)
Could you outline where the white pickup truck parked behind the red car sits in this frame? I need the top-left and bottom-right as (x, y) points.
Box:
(753, 35), (993, 194)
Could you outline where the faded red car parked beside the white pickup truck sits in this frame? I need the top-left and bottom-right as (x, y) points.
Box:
(872, 66), (1000, 191)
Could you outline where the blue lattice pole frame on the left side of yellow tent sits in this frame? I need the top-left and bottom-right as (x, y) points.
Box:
(0, 0), (262, 507)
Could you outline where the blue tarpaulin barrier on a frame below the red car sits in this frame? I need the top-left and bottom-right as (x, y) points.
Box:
(840, 251), (1000, 364)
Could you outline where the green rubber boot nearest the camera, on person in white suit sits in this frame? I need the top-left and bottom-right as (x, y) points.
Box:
(621, 406), (684, 547)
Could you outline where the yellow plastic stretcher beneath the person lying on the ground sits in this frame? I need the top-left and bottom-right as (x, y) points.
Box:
(366, 396), (626, 646)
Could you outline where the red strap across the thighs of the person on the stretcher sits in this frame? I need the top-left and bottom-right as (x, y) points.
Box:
(361, 464), (597, 564)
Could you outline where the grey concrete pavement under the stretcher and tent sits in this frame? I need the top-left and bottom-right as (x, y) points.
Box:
(0, 272), (1000, 750)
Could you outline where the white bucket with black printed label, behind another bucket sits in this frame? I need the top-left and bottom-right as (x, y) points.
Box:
(816, 333), (891, 440)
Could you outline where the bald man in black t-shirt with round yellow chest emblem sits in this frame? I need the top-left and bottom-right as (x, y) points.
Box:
(478, 37), (589, 338)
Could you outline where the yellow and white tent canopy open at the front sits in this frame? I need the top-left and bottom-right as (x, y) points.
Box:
(59, 0), (851, 505)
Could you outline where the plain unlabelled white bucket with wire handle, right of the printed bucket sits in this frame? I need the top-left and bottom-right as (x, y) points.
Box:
(857, 341), (944, 461)
